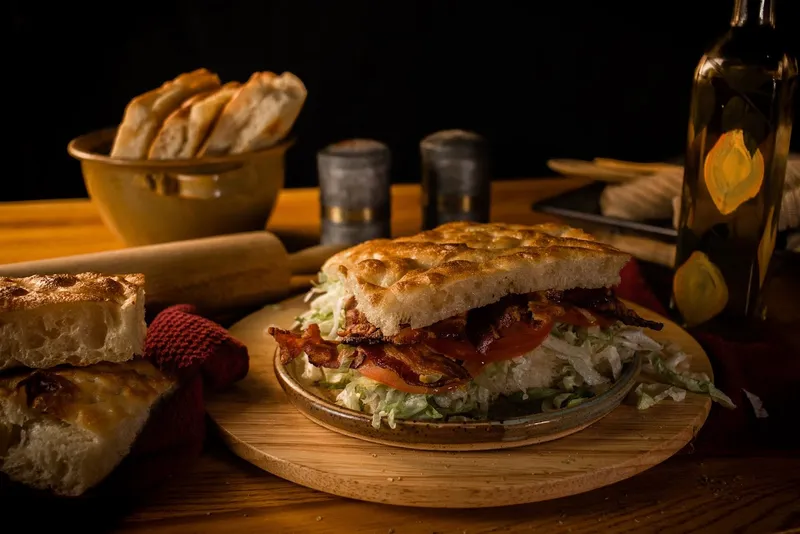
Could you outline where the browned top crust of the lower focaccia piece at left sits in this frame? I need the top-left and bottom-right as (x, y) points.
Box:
(0, 359), (175, 437)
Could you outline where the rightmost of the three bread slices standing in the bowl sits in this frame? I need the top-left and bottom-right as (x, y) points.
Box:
(198, 72), (306, 156)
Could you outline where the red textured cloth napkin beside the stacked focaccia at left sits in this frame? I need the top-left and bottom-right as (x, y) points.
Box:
(103, 305), (250, 494)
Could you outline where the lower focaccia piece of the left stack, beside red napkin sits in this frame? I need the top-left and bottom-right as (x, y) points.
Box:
(0, 359), (176, 496)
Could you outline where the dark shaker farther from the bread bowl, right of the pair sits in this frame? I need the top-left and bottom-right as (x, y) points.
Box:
(420, 130), (491, 230)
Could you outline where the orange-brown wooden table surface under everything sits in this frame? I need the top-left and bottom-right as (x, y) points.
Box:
(0, 179), (800, 534)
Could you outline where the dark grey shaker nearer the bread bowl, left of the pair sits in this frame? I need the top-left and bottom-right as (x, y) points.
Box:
(317, 139), (391, 245)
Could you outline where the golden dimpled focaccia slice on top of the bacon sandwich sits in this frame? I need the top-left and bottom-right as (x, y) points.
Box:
(322, 222), (630, 336)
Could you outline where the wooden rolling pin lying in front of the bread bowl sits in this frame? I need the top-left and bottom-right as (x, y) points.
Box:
(0, 231), (344, 313)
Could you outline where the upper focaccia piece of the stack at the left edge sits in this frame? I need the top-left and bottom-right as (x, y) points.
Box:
(0, 273), (147, 370)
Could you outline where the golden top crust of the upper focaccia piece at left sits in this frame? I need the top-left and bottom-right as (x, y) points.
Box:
(0, 273), (144, 313)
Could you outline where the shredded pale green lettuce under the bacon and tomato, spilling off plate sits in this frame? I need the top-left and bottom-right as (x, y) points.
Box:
(282, 274), (735, 428)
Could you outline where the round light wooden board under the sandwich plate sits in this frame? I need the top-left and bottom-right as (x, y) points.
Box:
(207, 296), (712, 508)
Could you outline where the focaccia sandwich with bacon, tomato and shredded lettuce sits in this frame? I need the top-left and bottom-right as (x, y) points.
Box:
(268, 222), (663, 426)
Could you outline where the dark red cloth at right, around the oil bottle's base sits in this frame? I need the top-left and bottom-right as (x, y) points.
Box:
(616, 260), (800, 454)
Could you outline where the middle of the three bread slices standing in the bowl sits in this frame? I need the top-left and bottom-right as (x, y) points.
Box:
(148, 82), (241, 159)
